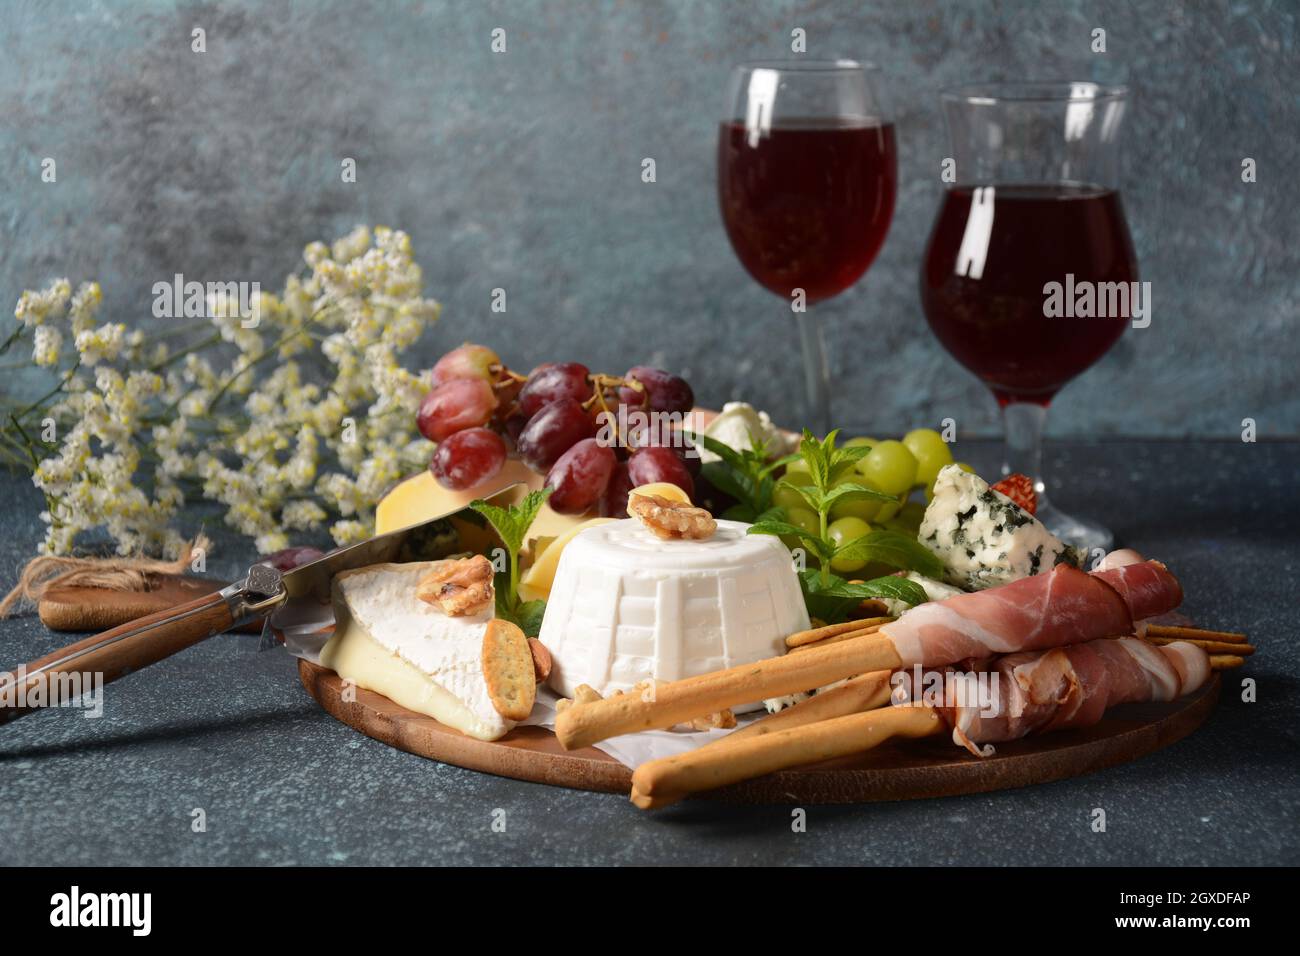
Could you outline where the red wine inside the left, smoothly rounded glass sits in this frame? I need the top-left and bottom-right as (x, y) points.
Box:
(718, 117), (897, 304)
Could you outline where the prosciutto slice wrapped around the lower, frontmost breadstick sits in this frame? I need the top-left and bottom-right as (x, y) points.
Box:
(936, 637), (1210, 757)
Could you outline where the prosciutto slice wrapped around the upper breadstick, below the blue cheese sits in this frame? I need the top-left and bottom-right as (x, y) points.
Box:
(880, 561), (1183, 667)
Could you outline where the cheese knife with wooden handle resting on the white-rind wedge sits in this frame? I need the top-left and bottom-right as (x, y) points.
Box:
(0, 483), (525, 723)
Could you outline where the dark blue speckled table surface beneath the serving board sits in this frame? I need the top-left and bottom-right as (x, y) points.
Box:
(0, 441), (1300, 865)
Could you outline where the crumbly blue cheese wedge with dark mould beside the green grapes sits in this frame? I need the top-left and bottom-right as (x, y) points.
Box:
(917, 464), (1084, 591)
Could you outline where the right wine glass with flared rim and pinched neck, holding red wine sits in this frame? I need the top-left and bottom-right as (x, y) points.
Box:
(920, 82), (1138, 551)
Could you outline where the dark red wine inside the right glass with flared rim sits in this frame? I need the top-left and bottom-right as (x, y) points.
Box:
(920, 183), (1138, 406)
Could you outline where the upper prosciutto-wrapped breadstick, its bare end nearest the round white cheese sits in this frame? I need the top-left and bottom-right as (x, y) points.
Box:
(555, 561), (1182, 749)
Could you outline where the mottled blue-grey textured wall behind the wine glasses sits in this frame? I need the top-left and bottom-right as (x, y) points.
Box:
(0, 0), (1300, 436)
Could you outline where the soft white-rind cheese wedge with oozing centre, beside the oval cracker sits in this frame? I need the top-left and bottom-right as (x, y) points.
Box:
(321, 562), (515, 740)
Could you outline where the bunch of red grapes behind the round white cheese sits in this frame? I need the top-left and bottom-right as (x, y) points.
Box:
(416, 343), (699, 518)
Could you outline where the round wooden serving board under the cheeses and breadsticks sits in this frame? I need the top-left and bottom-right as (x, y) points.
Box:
(298, 659), (1219, 804)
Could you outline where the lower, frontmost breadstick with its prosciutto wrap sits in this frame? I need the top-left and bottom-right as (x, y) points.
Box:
(631, 637), (1210, 809)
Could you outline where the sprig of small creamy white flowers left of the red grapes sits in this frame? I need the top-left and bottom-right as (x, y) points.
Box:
(0, 226), (439, 555)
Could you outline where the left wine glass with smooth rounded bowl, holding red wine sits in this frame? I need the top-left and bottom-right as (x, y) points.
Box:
(718, 60), (898, 434)
